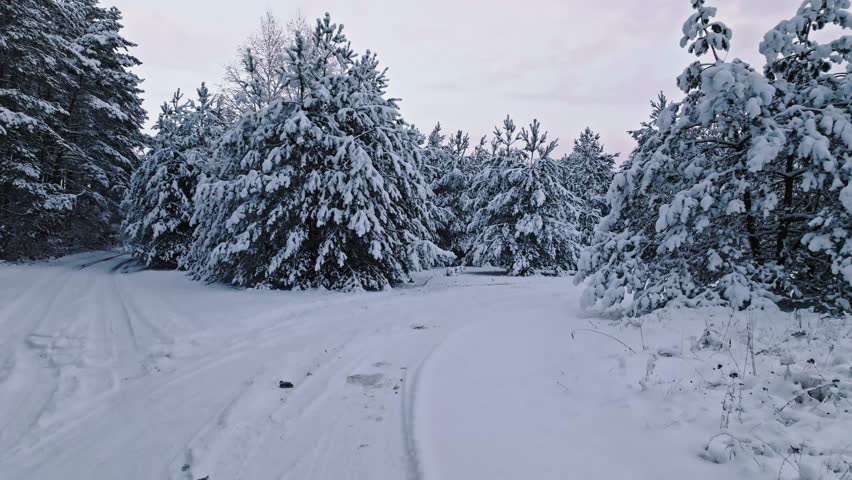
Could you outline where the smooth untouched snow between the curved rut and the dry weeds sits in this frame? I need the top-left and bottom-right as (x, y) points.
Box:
(418, 302), (724, 480)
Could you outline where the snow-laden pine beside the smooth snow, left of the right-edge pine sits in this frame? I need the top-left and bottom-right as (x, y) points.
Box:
(576, 0), (774, 314)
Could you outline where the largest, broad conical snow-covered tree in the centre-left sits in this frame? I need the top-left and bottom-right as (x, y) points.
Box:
(190, 15), (451, 290)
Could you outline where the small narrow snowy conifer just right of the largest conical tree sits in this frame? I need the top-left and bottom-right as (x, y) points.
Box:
(423, 124), (478, 260)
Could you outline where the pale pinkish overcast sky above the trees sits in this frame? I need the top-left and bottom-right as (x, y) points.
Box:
(103, 0), (801, 155)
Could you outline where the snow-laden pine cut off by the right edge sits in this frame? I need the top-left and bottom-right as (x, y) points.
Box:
(760, 0), (852, 312)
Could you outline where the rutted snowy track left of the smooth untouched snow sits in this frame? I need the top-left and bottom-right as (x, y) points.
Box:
(0, 253), (580, 479)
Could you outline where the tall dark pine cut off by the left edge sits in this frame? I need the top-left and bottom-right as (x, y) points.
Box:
(0, 0), (74, 258)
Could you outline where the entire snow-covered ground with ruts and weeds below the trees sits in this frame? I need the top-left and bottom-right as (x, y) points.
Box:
(0, 252), (852, 480)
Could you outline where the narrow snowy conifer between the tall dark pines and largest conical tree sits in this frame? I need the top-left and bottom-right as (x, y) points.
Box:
(123, 84), (225, 269)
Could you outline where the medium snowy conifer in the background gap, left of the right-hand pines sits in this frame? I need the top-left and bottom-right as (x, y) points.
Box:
(468, 117), (582, 276)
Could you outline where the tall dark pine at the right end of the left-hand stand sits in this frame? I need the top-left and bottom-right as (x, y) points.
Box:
(60, 0), (147, 248)
